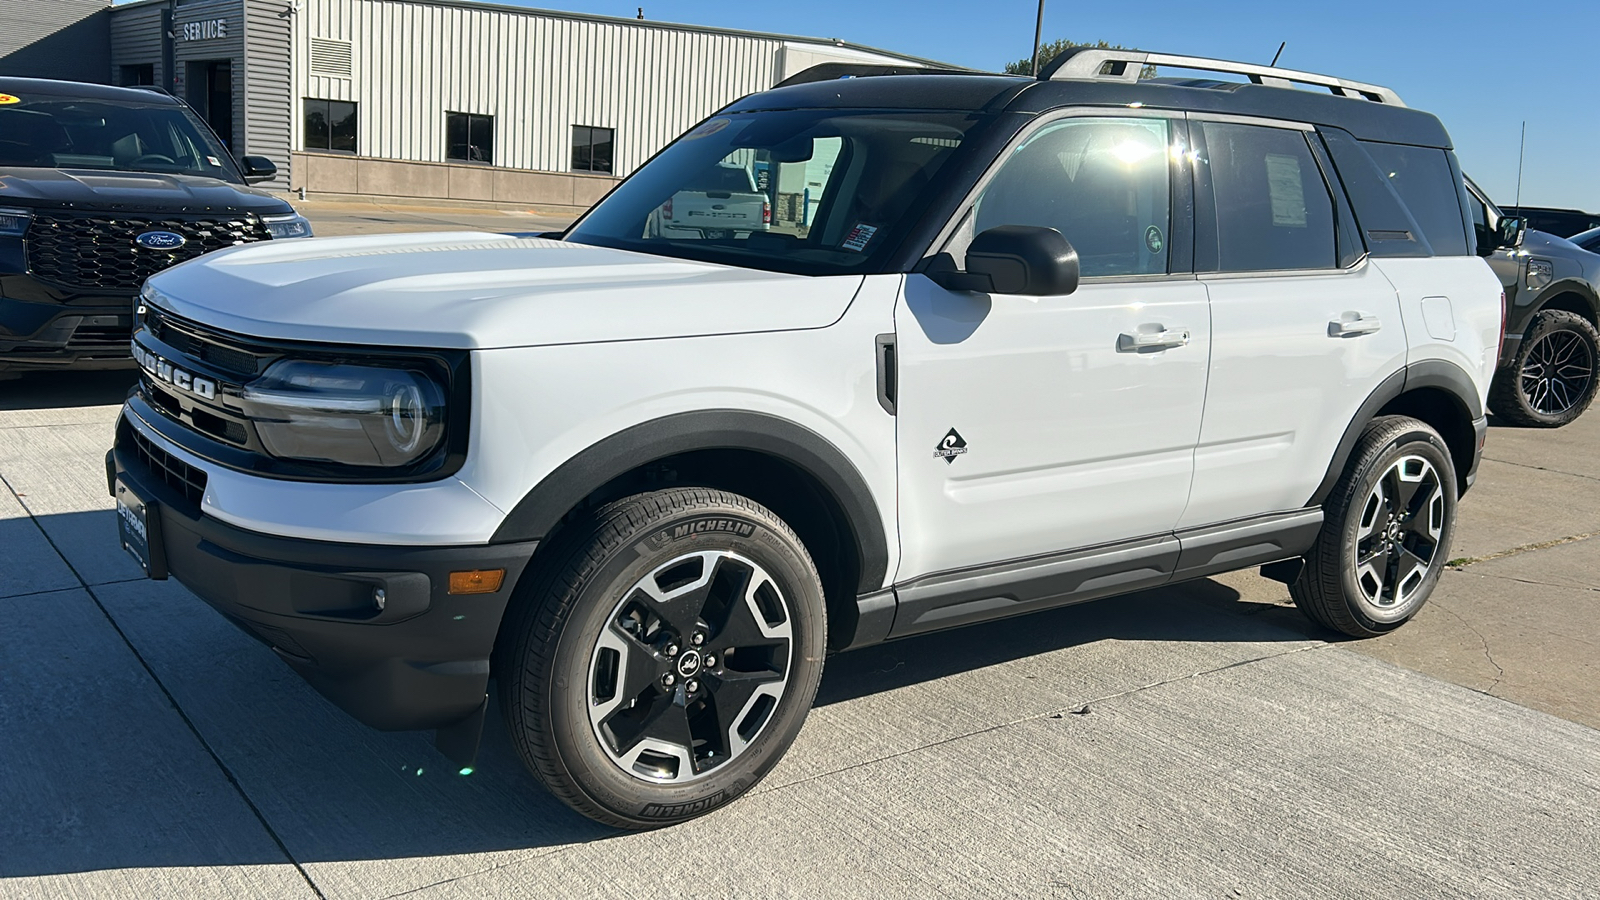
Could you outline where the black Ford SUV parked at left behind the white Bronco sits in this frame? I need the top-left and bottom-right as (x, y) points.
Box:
(0, 78), (310, 373)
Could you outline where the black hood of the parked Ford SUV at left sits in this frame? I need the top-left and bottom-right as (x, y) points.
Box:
(0, 167), (294, 215)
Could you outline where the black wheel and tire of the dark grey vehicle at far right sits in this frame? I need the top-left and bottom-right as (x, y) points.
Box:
(1490, 309), (1600, 428)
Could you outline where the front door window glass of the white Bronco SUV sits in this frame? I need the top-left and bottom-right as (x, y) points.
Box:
(973, 119), (1171, 275)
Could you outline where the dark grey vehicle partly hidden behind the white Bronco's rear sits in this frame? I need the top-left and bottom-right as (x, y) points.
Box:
(1467, 179), (1600, 428)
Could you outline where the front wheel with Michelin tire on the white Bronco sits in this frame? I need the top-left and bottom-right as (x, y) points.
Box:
(496, 488), (826, 828)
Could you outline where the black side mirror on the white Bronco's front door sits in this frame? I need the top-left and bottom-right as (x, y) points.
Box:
(928, 226), (1078, 296)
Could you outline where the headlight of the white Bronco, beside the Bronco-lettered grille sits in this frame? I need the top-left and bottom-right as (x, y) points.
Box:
(240, 359), (445, 468)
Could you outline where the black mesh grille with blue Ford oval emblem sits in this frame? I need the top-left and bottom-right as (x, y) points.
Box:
(27, 210), (270, 290)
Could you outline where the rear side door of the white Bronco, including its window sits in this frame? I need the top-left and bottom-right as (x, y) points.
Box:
(1181, 115), (1406, 527)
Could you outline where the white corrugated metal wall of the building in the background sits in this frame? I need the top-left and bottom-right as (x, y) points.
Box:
(291, 0), (915, 175)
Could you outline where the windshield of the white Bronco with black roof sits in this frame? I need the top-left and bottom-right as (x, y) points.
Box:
(566, 109), (979, 275)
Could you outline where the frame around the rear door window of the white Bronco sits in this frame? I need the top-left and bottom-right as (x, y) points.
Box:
(1184, 112), (1366, 279)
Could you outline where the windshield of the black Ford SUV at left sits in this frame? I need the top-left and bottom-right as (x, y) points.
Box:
(0, 96), (242, 183)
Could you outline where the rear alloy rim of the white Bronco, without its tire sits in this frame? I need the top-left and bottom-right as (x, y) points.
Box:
(1355, 456), (1445, 617)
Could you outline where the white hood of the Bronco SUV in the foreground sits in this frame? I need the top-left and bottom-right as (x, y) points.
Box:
(149, 232), (862, 349)
